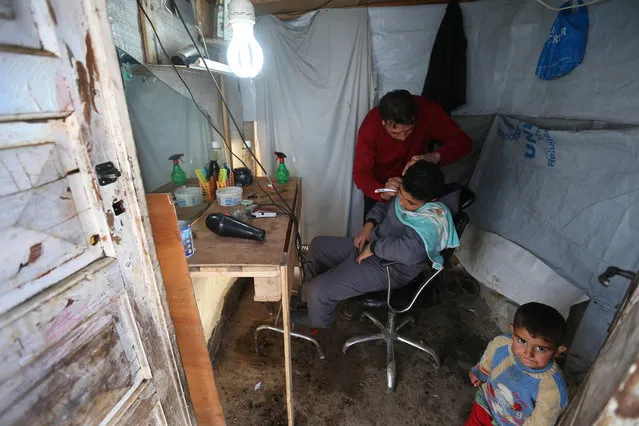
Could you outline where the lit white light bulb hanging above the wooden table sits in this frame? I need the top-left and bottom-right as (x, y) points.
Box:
(226, 0), (264, 78)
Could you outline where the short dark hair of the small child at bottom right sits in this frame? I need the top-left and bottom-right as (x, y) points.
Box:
(513, 302), (566, 346)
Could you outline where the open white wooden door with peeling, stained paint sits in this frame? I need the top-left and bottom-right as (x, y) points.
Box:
(0, 0), (195, 425)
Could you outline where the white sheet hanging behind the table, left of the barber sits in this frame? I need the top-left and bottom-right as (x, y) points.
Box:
(255, 9), (371, 241)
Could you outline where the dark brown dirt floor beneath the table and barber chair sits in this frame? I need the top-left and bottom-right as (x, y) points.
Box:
(214, 272), (510, 426)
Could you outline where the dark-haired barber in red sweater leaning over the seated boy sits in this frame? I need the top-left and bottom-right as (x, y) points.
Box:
(353, 90), (472, 218)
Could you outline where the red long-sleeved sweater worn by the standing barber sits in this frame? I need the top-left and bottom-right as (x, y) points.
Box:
(353, 96), (472, 201)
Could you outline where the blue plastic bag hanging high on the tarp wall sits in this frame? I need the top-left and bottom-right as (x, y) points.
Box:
(536, 0), (588, 80)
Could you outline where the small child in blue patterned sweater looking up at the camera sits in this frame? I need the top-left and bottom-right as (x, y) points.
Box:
(466, 303), (568, 426)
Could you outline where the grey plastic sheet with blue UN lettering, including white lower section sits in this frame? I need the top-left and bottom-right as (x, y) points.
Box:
(459, 116), (639, 372)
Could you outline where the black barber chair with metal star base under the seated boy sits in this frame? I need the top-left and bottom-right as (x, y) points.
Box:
(342, 184), (475, 391)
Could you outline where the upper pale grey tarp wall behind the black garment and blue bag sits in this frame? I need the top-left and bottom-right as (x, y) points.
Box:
(369, 0), (639, 124)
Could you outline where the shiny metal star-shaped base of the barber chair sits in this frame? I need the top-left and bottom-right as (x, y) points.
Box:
(342, 312), (439, 391)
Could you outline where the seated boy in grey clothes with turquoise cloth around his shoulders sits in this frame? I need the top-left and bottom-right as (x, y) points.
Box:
(291, 160), (459, 327)
